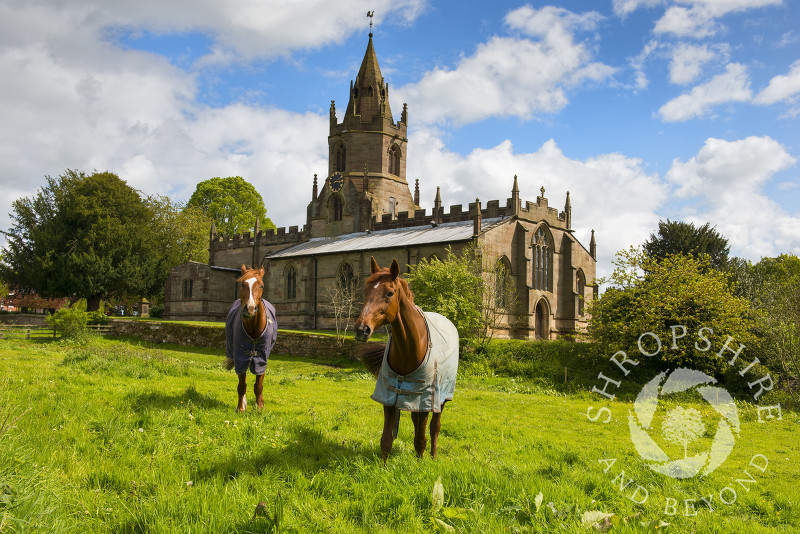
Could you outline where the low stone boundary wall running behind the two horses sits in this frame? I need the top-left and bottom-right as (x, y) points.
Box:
(111, 319), (363, 361)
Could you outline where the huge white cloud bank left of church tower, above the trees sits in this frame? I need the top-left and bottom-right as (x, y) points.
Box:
(0, 0), (328, 239)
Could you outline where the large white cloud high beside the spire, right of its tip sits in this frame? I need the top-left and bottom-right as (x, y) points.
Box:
(394, 6), (613, 124)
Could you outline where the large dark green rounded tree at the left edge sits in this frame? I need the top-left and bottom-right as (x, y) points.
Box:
(0, 170), (160, 311)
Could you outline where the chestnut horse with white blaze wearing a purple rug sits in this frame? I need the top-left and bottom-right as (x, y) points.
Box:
(224, 265), (278, 412)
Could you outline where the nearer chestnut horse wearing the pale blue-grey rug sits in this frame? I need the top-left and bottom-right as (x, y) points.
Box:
(354, 257), (458, 462)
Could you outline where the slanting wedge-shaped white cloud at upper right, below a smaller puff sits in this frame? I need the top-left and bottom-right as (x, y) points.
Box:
(658, 63), (752, 122)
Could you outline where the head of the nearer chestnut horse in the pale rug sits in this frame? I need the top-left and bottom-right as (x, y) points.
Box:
(354, 257), (410, 341)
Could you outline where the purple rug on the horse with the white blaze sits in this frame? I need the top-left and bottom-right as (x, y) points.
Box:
(225, 299), (278, 375)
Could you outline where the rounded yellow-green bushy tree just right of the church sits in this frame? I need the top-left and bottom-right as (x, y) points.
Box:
(589, 249), (757, 375)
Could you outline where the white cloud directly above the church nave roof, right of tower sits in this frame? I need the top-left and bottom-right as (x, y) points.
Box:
(408, 129), (667, 276)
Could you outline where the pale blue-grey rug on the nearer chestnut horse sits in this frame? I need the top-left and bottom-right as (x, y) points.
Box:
(372, 312), (458, 413)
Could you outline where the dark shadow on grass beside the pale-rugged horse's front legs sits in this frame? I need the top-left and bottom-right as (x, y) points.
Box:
(195, 424), (380, 482)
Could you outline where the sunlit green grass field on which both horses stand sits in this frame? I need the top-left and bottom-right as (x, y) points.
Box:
(0, 339), (800, 533)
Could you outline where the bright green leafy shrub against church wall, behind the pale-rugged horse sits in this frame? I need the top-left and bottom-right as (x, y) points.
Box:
(406, 246), (483, 338)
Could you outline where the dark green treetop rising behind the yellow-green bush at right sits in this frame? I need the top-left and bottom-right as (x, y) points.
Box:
(644, 219), (730, 269)
